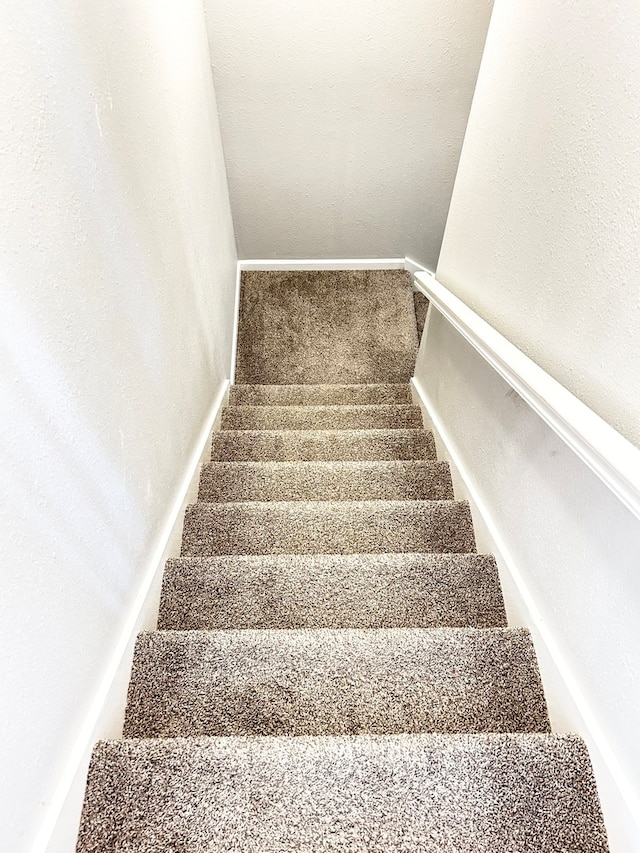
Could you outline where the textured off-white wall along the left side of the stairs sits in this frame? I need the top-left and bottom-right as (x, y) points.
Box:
(0, 0), (236, 853)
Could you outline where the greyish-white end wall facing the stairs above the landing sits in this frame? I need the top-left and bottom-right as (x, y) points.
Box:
(205, 0), (491, 269)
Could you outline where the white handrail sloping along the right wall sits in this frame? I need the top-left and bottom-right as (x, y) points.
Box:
(415, 272), (640, 518)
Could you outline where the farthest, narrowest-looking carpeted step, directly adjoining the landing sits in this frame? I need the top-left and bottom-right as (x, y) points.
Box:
(229, 382), (411, 406)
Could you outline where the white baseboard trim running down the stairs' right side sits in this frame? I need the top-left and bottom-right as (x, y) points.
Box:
(411, 377), (640, 853)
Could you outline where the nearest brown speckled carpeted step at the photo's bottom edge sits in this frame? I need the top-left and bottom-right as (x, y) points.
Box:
(77, 734), (608, 853)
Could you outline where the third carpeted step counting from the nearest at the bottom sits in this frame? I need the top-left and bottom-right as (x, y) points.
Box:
(158, 554), (507, 630)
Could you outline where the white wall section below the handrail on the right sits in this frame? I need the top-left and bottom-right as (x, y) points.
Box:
(416, 309), (640, 853)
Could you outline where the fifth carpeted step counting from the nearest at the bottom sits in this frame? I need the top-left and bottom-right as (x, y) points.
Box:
(198, 461), (453, 501)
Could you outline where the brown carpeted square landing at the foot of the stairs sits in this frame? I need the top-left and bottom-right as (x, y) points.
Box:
(236, 270), (418, 385)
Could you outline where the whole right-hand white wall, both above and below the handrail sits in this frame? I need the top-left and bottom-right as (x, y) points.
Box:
(416, 0), (640, 851)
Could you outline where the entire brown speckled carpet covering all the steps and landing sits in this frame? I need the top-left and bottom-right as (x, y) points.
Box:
(77, 271), (608, 853)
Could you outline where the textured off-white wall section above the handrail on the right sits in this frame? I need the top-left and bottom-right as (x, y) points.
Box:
(437, 0), (640, 445)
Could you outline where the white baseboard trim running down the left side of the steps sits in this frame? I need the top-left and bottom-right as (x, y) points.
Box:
(36, 380), (229, 853)
